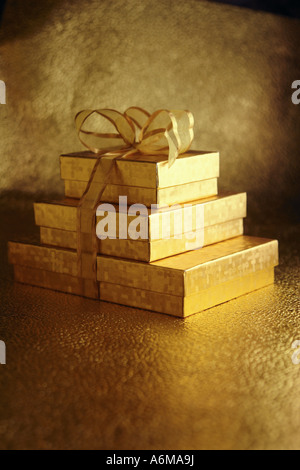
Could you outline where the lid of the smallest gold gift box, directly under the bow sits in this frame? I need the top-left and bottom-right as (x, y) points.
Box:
(60, 151), (220, 188)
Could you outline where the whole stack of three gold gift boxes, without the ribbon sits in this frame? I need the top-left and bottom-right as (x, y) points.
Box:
(9, 151), (278, 317)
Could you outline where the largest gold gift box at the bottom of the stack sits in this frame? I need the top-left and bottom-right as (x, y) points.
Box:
(9, 236), (278, 317)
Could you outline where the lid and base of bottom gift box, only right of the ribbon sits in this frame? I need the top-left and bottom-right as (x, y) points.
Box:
(98, 236), (278, 317)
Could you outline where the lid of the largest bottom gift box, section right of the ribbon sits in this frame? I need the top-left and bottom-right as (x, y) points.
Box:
(98, 236), (278, 296)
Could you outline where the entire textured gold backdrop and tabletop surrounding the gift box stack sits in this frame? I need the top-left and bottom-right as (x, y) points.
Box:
(0, 0), (300, 449)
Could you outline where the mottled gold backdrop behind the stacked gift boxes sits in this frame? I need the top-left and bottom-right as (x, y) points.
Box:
(0, 0), (300, 217)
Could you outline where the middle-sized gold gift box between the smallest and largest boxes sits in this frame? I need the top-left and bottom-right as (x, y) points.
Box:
(34, 193), (247, 262)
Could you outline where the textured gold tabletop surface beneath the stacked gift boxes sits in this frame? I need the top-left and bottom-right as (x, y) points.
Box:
(0, 198), (300, 450)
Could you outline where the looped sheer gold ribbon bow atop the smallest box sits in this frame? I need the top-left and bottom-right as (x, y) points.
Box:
(75, 107), (194, 167)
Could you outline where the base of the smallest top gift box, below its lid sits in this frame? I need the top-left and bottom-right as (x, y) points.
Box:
(65, 178), (218, 207)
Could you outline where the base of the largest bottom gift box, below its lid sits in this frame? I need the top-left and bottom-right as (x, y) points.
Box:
(14, 265), (274, 317)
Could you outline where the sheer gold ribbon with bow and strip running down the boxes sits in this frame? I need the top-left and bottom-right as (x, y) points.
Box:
(75, 107), (194, 298)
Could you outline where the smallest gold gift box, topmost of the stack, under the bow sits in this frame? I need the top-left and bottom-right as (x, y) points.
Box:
(60, 151), (220, 207)
